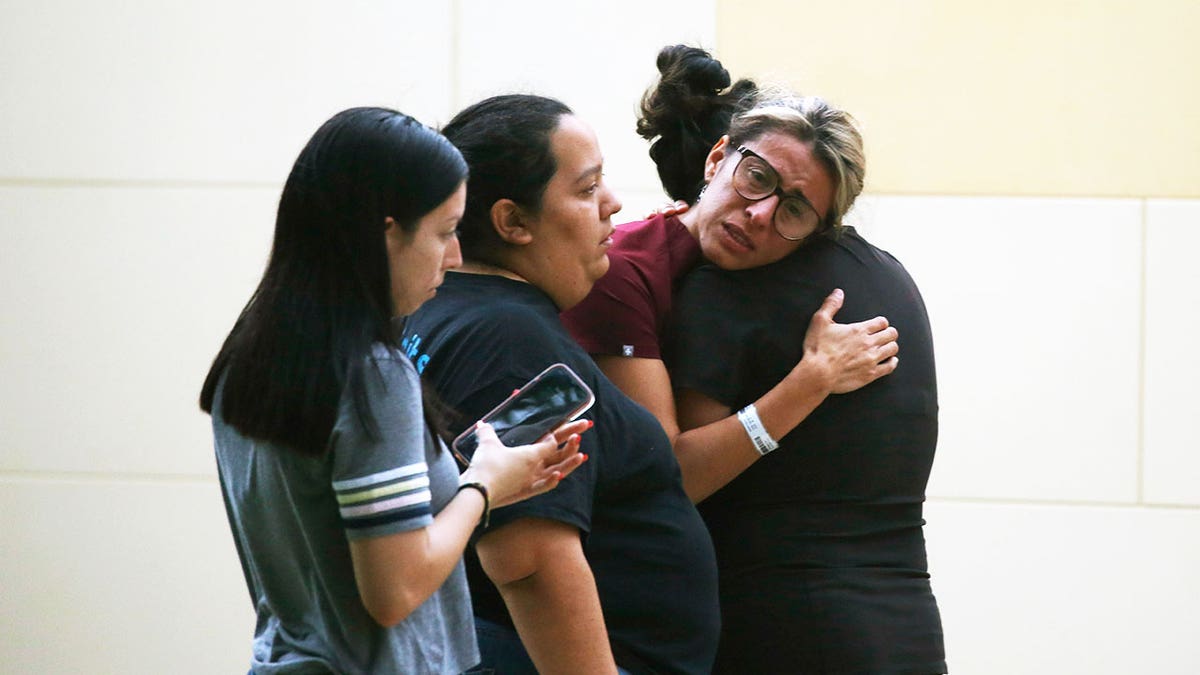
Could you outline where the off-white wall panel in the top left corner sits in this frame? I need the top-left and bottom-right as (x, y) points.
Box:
(0, 0), (450, 183)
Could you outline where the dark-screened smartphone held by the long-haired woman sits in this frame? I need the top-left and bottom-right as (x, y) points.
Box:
(450, 363), (596, 466)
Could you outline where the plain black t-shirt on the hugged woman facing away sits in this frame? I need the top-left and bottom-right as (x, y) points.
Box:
(667, 228), (946, 673)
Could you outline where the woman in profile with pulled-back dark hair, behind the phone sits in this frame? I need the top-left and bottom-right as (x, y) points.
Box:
(404, 95), (719, 674)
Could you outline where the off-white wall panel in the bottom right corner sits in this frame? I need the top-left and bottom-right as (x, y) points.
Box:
(925, 500), (1200, 675)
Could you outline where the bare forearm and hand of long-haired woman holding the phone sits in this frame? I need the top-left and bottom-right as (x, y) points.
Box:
(350, 419), (590, 626)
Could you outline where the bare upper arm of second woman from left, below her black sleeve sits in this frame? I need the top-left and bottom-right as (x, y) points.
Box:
(475, 518), (617, 675)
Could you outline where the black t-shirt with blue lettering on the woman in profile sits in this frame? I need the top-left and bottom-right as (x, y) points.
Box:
(403, 274), (720, 674)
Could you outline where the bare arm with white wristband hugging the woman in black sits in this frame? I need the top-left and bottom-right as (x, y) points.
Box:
(596, 291), (899, 502)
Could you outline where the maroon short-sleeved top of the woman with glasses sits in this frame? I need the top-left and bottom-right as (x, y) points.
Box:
(562, 215), (700, 359)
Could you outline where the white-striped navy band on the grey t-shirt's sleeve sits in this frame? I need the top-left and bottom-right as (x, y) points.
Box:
(334, 461), (432, 531)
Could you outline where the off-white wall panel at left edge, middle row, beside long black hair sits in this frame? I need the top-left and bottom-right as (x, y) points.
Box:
(0, 187), (278, 474)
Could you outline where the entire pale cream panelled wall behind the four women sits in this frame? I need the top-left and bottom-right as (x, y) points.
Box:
(0, 0), (1200, 675)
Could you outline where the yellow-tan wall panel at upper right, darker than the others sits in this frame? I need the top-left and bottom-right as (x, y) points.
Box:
(718, 0), (1200, 197)
